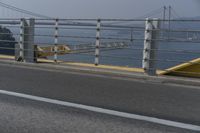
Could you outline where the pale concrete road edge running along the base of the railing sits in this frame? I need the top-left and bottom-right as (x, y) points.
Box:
(0, 59), (200, 87)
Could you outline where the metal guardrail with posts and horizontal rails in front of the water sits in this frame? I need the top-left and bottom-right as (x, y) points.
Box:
(0, 19), (200, 75)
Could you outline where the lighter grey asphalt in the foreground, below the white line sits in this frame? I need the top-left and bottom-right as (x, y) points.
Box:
(0, 95), (196, 133)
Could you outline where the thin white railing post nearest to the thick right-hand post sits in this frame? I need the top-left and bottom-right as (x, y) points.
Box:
(95, 19), (101, 66)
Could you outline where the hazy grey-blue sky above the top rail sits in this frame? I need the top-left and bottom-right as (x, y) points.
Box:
(0, 0), (200, 18)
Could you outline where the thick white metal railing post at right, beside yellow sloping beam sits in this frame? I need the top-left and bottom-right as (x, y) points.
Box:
(143, 19), (160, 76)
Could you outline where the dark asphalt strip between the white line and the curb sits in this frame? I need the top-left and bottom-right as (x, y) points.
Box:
(0, 66), (200, 129)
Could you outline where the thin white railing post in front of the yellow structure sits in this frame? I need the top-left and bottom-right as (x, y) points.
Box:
(54, 19), (59, 63)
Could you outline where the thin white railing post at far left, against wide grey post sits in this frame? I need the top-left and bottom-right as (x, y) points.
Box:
(17, 18), (25, 61)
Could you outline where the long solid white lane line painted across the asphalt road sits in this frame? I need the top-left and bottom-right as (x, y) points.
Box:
(0, 90), (200, 131)
